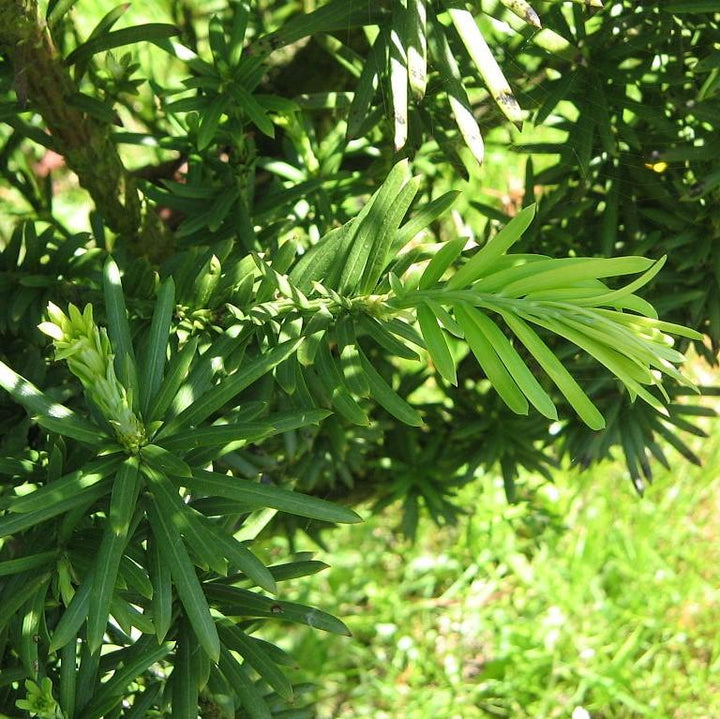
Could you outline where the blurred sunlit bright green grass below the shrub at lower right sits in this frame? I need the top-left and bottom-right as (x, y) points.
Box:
(258, 424), (720, 719)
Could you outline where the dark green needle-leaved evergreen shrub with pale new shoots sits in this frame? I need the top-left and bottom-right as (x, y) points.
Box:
(0, 0), (720, 719)
